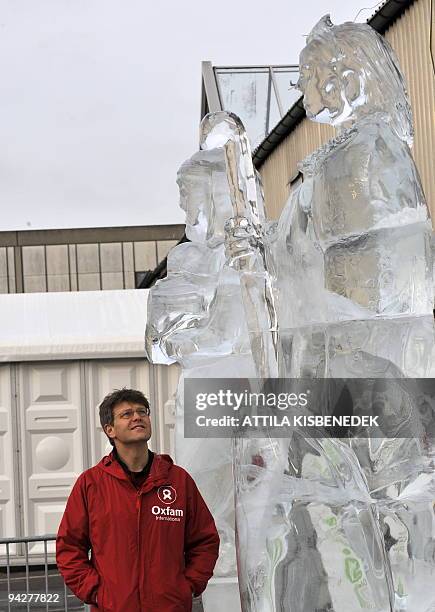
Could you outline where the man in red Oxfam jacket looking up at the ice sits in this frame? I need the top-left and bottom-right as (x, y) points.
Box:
(56, 389), (219, 612)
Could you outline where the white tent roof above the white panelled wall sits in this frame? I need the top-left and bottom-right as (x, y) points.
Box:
(0, 289), (148, 362)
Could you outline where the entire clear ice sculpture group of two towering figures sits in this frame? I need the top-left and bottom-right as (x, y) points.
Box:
(147, 17), (435, 612)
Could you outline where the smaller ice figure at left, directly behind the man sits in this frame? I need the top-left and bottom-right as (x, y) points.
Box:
(146, 113), (262, 576)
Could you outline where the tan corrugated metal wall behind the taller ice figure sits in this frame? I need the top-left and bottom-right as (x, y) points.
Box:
(260, 0), (435, 220)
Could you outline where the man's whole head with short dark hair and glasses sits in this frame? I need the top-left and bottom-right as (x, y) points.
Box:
(99, 388), (151, 446)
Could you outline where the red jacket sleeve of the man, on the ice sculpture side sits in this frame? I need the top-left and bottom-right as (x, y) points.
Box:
(184, 474), (219, 595)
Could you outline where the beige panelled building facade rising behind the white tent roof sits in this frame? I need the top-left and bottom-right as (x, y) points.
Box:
(0, 225), (184, 293)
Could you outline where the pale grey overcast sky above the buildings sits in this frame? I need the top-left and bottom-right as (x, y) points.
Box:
(0, 0), (375, 230)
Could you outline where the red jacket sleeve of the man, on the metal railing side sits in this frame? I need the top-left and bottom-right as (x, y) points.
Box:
(56, 474), (99, 603)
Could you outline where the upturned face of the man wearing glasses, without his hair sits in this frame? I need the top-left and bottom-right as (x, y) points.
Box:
(104, 402), (151, 444)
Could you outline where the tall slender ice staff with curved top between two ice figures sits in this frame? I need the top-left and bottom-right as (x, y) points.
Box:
(200, 111), (279, 378)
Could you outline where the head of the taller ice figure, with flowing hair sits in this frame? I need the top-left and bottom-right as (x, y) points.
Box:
(298, 15), (412, 142)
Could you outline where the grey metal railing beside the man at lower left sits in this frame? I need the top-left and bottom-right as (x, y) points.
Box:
(0, 535), (90, 612)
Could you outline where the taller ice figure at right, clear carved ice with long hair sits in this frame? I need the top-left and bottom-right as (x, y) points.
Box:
(228, 17), (435, 612)
